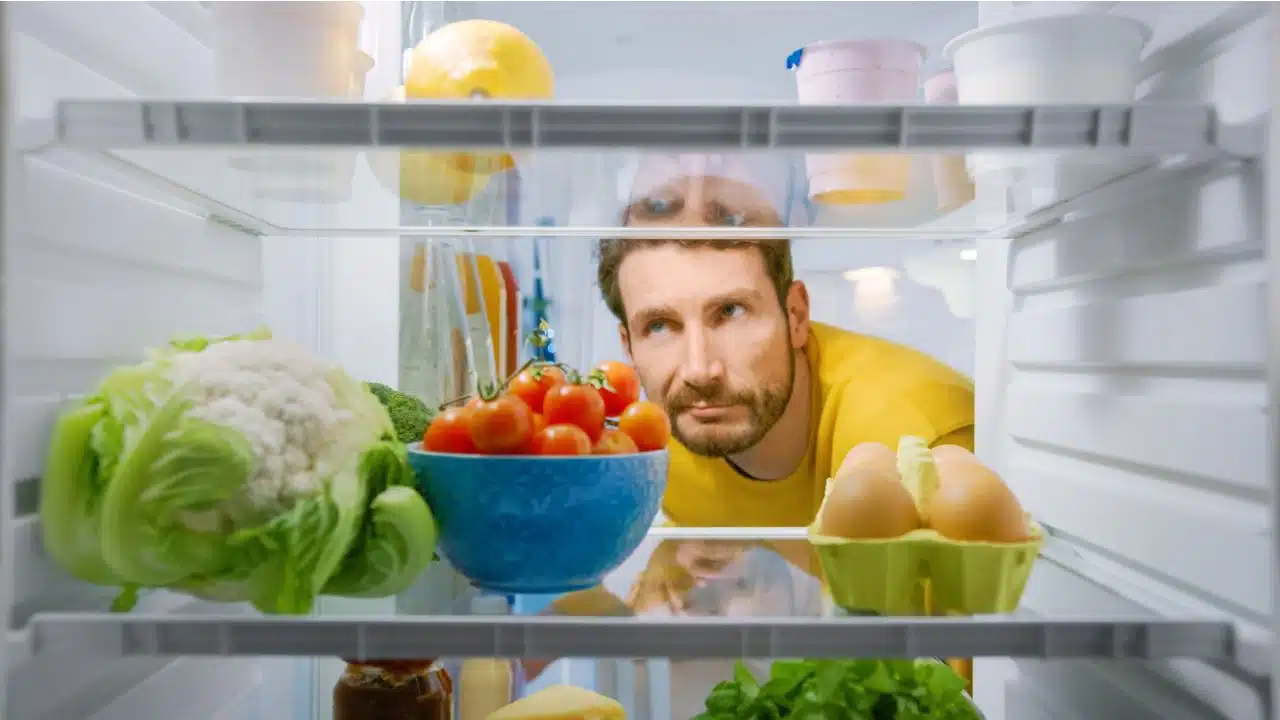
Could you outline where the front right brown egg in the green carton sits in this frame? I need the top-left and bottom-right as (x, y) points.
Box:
(925, 448), (1027, 543)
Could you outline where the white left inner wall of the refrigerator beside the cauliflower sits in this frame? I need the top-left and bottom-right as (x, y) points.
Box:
(0, 3), (323, 720)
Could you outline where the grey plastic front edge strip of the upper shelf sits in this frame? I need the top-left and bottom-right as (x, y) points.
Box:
(54, 100), (1258, 154)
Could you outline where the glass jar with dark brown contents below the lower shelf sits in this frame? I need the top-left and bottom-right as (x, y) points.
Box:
(333, 660), (453, 720)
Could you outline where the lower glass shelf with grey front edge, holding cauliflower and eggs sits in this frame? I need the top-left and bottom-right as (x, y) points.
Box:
(24, 528), (1236, 660)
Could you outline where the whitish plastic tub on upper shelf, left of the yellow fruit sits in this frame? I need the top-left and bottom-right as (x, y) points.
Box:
(210, 0), (365, 99)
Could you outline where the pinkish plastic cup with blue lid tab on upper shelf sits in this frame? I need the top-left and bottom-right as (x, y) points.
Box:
(796, 40), (924, 205)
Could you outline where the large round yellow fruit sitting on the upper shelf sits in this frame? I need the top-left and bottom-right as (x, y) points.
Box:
(404, 19), (556, 173)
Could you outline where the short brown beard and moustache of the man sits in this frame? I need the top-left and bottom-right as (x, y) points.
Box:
(667, 350), (796, 457)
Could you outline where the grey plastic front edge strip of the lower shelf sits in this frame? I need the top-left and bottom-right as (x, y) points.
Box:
(29, 614), (1235, 660)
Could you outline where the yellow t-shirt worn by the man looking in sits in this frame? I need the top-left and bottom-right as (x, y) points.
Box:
(662, 323), (974, 528)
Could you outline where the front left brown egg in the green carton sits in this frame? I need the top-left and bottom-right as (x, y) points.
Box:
(818, 465), (920, 539)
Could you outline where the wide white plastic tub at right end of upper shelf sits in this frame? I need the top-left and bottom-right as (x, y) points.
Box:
(943, 14), (1151, 177)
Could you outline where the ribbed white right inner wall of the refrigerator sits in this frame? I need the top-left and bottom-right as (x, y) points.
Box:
(975, 3), (1276, 720)
